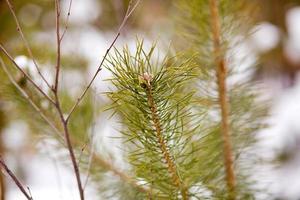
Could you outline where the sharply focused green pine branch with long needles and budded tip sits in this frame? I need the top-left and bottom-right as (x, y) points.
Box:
(107, 42), (196, 199)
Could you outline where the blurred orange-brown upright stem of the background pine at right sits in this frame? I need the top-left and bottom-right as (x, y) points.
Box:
(210, 0), (236, 200)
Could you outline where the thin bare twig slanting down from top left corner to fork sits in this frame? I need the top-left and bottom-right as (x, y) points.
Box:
(6, 0), (51, 89)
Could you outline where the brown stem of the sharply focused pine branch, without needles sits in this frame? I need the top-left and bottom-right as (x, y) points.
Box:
(146, 80), (188, 200)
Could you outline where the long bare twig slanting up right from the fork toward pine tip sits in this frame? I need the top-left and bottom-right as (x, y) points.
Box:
(66, 0), (141, 121)
